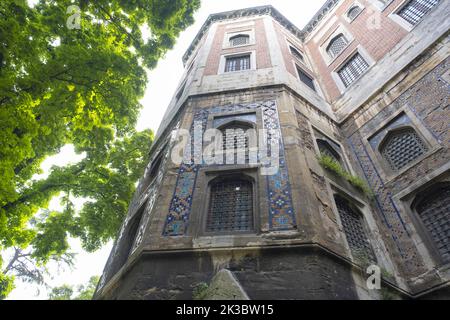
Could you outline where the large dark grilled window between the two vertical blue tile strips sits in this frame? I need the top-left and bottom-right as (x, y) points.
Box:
(206, 177), (253, 232)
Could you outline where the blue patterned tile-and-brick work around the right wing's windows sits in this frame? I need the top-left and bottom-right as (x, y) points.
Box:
(348, 59), (450, 274)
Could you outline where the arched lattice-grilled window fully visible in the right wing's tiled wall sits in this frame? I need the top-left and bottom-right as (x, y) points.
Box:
(380, 128), (427, 171)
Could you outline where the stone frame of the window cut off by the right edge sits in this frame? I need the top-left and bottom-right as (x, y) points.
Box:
(392, 166), (450, 270)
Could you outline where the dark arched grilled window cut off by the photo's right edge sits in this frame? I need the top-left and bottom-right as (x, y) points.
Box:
(416, 185), (450, 262)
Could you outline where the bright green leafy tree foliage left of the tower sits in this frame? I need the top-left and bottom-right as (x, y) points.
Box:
(0, 0), (199, 298)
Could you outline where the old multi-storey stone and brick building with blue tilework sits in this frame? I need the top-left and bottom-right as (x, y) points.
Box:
(96, 0), (450, 299)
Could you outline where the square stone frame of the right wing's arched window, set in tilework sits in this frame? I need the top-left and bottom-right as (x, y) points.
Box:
(362, 104), (442, 183)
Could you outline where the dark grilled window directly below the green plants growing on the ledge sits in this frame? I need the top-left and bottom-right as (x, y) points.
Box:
(334, 196), (376, 262)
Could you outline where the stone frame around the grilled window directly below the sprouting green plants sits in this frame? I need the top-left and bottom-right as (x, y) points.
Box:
(325, 181), (398, 275)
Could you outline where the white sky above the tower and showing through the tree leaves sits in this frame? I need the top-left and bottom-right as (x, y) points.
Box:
(8, 0), (325, 300)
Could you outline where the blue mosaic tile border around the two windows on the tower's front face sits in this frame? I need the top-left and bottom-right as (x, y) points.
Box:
(163, 101), (296, 236)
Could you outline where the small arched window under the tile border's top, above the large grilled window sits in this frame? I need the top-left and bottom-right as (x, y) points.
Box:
(220, 121), (252, 164)
